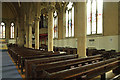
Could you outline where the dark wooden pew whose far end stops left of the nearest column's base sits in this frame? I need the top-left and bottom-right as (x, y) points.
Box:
(25, 54), (78, 78)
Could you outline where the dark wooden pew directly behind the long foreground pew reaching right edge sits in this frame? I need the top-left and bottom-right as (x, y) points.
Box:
(26, 55), (101, 78)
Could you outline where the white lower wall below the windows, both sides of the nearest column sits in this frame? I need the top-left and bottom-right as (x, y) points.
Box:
(53, 35), (120, 51)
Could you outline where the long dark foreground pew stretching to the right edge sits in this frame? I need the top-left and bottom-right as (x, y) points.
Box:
(37, 57), (120, 80)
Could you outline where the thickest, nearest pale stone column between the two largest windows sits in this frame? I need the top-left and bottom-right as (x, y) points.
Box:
(74, 2), (87, 57)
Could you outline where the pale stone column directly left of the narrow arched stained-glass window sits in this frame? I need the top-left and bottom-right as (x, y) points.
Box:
(48, 10), (53, 51)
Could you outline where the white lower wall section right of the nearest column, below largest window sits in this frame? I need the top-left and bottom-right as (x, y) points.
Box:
(86, 35), (119, 51)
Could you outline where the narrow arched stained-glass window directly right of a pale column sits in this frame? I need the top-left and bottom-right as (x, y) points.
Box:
(53, 11), (58, 38)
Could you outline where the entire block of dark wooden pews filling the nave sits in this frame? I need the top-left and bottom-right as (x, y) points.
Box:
(3, 44), (120, 80)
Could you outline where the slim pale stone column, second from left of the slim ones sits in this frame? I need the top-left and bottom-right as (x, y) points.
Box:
(35, 17), (39, 49)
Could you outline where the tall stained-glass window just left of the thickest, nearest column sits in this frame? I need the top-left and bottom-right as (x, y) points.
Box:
(66, 2), (74, 37)
